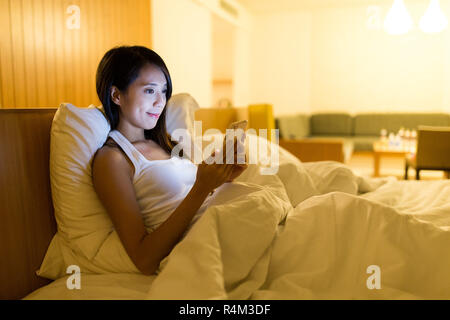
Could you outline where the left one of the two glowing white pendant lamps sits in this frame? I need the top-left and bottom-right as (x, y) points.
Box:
(384, 0), (413, 35)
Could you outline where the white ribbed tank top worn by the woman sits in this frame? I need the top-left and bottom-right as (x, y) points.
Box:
(109, 130), (211, 232)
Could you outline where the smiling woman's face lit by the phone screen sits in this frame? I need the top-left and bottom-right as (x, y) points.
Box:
(118, 64), (167, 130)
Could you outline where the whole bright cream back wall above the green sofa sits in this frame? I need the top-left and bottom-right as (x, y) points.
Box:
(250, 0), (450, 115)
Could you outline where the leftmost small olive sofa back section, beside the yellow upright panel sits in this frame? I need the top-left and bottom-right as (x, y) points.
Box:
(276, 114), (310, 139)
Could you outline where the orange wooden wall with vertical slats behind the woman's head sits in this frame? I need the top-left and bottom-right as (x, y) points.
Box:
(0, 0), (151, 108)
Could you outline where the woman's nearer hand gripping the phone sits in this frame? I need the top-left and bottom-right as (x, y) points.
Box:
(195, 152), (235, 192)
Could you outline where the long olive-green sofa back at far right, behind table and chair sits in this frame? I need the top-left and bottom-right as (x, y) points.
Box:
(354, 113), (450, 136)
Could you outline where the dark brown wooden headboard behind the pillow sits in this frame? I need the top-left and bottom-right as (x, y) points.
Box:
(0, 109), (56, 299)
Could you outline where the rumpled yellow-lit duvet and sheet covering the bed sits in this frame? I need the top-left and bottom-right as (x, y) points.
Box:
(27, 140), (450, 299)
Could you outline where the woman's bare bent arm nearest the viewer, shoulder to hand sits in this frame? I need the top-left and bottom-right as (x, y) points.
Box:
(92, 147), (232, 275)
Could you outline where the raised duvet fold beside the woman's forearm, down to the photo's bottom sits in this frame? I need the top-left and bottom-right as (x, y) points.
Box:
(148, 183), (293, 299)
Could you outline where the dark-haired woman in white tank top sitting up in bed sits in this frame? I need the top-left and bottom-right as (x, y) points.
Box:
(92, 46), (245, 275)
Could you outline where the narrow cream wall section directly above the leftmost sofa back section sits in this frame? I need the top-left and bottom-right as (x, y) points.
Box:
(250, 11), (311, 115)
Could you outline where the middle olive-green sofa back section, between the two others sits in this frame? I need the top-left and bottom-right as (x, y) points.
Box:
(310, 113), (353, 136)
